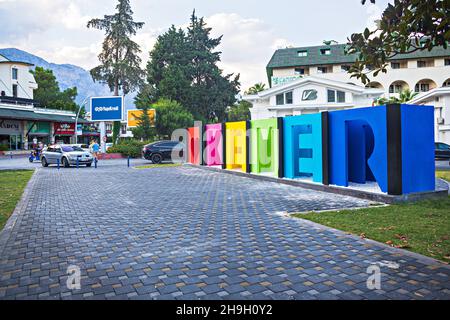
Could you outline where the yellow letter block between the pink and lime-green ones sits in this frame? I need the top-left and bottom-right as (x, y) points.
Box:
(225, 121), (250, 172)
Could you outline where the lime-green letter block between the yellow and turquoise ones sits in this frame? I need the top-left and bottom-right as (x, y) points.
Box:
(250, 118), (282, 176)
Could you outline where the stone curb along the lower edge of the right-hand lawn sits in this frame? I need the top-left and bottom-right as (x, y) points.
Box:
(289, 216), (450, 269)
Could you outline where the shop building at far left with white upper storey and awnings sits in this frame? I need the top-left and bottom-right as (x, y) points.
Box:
(0, 55), (87, 151)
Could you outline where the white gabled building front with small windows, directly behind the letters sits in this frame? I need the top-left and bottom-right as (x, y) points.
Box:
(242, 76), (384, 120)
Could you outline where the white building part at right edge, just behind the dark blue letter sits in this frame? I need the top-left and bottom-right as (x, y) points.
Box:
(408, 86), (450, 145)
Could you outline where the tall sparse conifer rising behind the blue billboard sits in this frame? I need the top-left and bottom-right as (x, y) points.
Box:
(87, 0), (144, 143)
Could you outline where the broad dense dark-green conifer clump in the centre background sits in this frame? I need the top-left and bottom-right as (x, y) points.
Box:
(136, 11), (240, 121)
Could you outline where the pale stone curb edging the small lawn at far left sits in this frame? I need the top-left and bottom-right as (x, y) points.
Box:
(0, 168), (41, 258)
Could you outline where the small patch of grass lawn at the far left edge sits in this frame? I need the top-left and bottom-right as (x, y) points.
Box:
(0, 170), (33, 230)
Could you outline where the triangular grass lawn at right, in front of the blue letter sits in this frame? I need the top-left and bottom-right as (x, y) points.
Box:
(294, 197), (450, 263)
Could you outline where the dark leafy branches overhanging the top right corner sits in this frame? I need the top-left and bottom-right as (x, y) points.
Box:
(347, 0), (450, 83)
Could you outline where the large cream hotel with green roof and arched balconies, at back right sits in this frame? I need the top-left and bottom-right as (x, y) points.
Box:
(267, 44), (450, 98)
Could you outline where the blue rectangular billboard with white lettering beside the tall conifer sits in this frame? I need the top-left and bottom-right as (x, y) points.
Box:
(91, 97), (123, 121)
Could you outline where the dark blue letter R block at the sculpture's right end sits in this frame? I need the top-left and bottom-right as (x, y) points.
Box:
(329, 105), (435, 195)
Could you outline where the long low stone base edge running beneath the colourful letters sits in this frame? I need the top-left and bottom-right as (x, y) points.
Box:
(185, 163), (448, 204)
